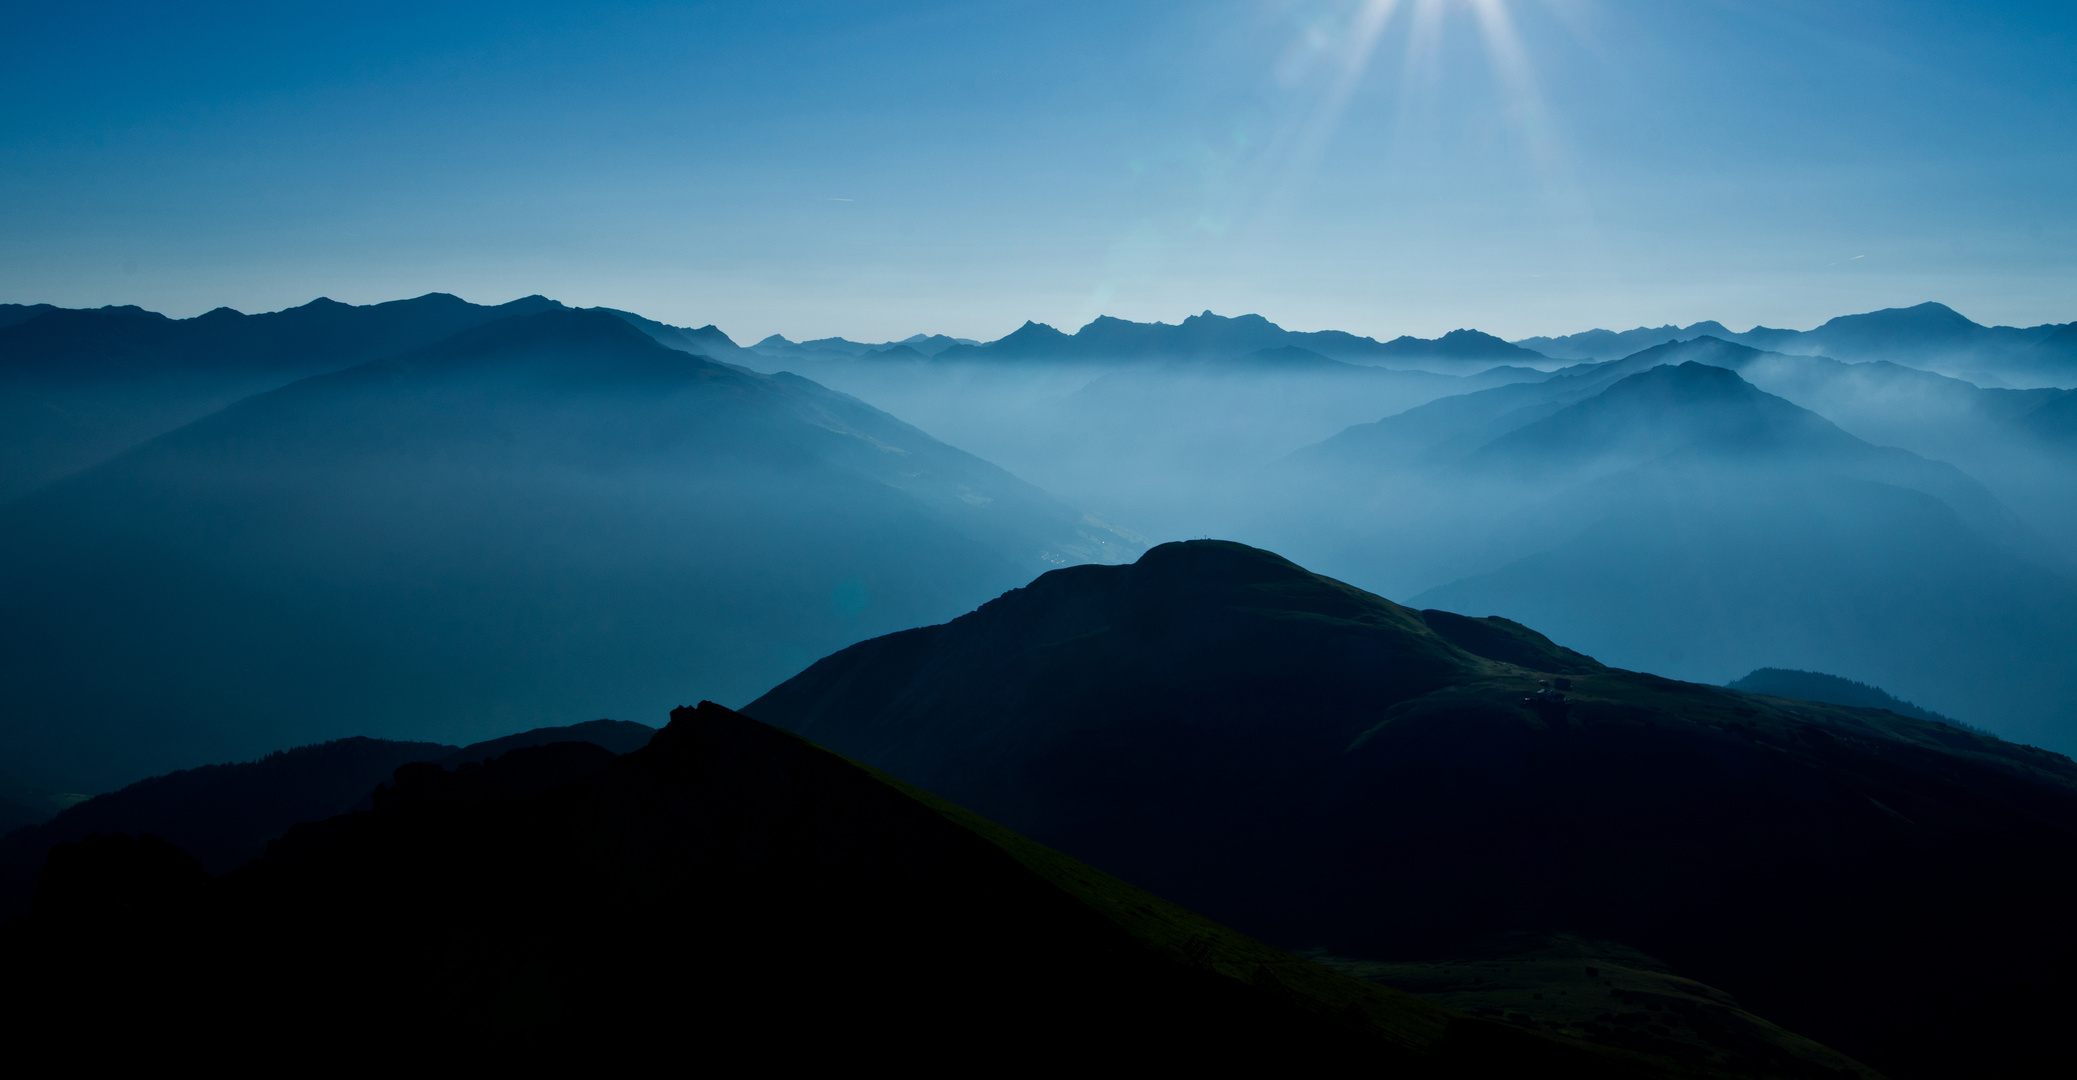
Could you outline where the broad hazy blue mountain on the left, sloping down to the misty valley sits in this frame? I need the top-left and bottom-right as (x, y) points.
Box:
(0, 312), (1130, 793)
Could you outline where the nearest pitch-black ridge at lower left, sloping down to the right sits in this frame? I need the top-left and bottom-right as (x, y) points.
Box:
(6, 704), (1611, 1076)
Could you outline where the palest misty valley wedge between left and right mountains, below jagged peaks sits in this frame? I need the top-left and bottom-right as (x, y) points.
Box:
(771, 334), (1543, 536)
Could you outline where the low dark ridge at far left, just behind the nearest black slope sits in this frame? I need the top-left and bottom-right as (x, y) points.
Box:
(0, 721), (656, 922)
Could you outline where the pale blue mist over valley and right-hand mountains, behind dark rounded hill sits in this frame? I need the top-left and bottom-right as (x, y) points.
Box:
(731, 305), (2077, 750)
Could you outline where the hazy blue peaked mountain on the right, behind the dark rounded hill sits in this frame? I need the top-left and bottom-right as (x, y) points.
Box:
(1250, 339), (2077, 746)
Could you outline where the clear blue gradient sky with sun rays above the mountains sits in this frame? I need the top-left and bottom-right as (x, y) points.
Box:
(0, 0), (2077, 341)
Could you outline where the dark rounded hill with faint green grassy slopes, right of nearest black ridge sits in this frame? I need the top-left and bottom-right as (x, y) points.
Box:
(746, 540), (2077, 1076)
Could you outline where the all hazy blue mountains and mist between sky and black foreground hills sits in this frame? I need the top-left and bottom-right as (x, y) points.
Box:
(0, 295), (2077, 804)
